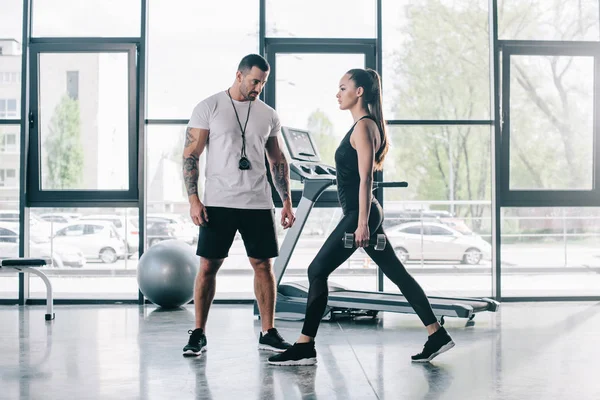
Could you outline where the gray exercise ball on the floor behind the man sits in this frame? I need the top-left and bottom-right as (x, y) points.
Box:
(137, 240), (200, 308)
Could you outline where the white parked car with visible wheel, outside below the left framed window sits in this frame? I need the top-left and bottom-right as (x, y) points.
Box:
(53, 220), (127, 264)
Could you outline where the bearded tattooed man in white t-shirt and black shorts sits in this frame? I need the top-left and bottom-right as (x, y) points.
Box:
(183, 54), (295, 356)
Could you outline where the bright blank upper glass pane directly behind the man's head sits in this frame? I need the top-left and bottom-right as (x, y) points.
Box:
(148, 0), (259, 120)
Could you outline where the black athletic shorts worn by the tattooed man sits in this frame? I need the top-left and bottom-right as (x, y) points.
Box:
(196, 207), (279, 259)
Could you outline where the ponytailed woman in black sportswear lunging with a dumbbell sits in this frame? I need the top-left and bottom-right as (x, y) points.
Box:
(269, 69), (454, 365)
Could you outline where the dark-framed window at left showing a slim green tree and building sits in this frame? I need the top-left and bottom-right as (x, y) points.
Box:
(27, 46), (138, 203)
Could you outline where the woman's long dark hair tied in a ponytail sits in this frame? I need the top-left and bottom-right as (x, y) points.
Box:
(347, 68), (390, 170)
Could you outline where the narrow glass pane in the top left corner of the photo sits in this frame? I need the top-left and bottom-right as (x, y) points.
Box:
(0, 0), (23, 119)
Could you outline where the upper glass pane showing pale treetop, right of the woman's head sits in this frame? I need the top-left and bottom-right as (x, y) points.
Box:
(382, 0), (490, 120)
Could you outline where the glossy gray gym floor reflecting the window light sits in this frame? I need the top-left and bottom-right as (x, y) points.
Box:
(0, 303), (600, 400)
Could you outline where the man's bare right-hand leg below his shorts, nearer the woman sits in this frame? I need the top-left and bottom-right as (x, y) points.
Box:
(248, 257), (276, 332)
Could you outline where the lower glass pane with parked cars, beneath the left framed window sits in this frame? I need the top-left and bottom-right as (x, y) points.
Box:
(30, 208), (139, 299)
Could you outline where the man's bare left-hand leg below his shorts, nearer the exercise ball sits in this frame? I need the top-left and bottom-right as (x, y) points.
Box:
(194, 257), (224, 331)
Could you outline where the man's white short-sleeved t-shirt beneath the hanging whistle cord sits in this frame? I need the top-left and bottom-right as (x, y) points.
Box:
(188, 91), (281, 209)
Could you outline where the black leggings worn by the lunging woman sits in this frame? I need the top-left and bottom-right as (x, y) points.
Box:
(302, 201), (437, 337)
